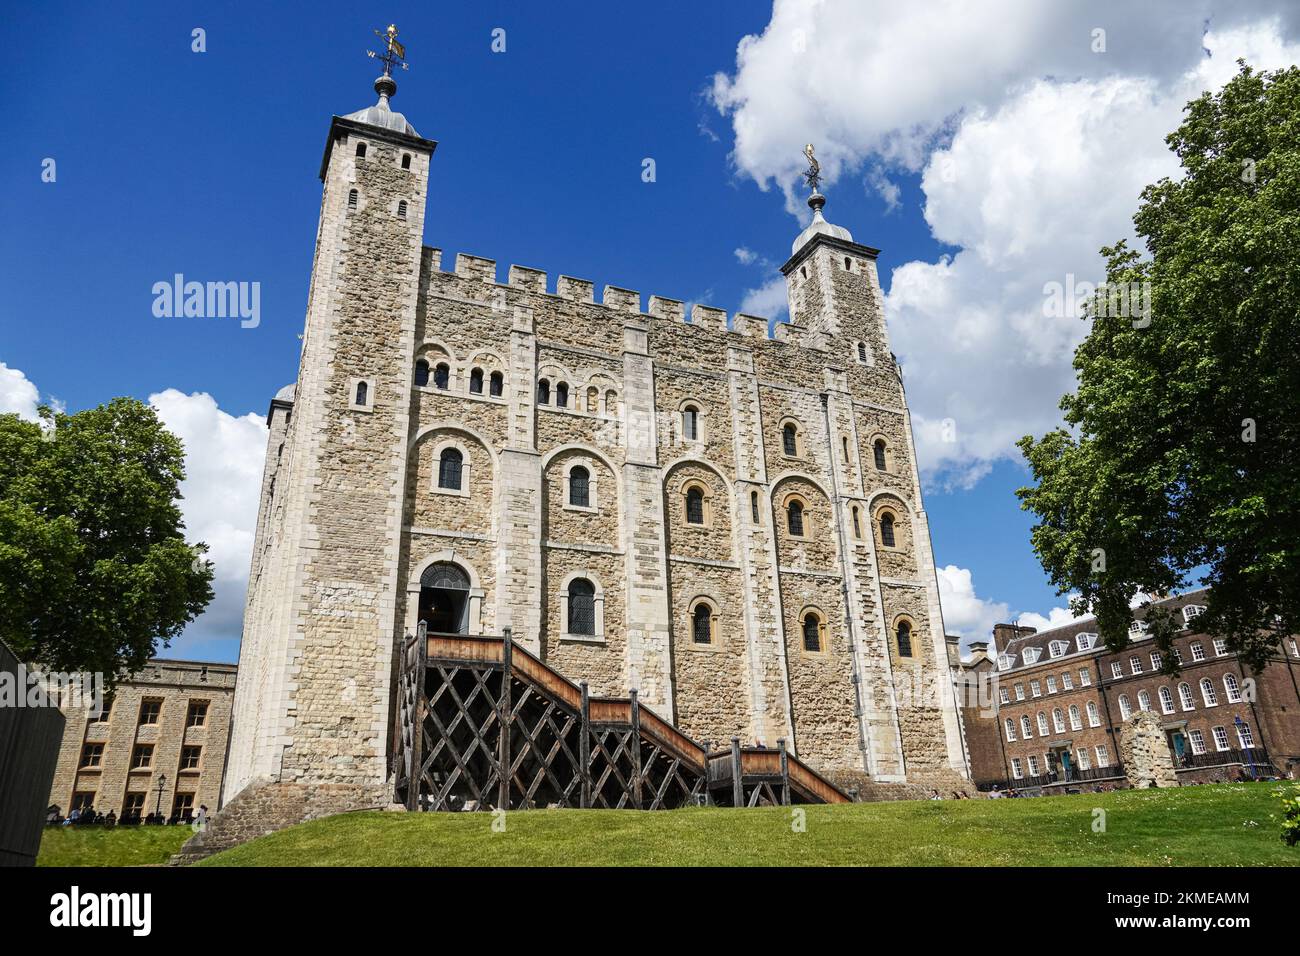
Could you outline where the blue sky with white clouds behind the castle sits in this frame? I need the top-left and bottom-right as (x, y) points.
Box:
(0, 1), (1294, 659)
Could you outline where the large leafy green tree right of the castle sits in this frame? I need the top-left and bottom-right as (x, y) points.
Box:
(1018, 62), (1300, 670)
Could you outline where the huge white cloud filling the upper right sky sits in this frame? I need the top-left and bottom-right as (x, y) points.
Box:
(712, 0), (1300, 486)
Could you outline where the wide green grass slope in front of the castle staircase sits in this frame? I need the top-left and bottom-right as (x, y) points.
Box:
(192, 783), (1300, 866)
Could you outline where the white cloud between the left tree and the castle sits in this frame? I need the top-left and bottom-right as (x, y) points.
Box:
(150, 389), (267, 657)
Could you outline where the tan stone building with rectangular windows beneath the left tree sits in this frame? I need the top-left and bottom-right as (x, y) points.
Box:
(49, 659), (235, 822)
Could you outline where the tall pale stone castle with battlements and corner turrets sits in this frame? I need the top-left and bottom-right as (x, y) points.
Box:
(225, 59), (966, 805)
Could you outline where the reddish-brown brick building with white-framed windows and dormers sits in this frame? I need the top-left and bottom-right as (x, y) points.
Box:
(961, 591), (1300, 793)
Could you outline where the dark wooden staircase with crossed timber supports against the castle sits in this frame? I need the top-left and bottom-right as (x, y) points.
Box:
(393, 622), (850, 810)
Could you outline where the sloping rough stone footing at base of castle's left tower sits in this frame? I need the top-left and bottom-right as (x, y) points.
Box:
(172, 782), (393, 866)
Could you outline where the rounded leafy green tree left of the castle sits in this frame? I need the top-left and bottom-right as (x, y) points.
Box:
(0, 398), (212, 680)
